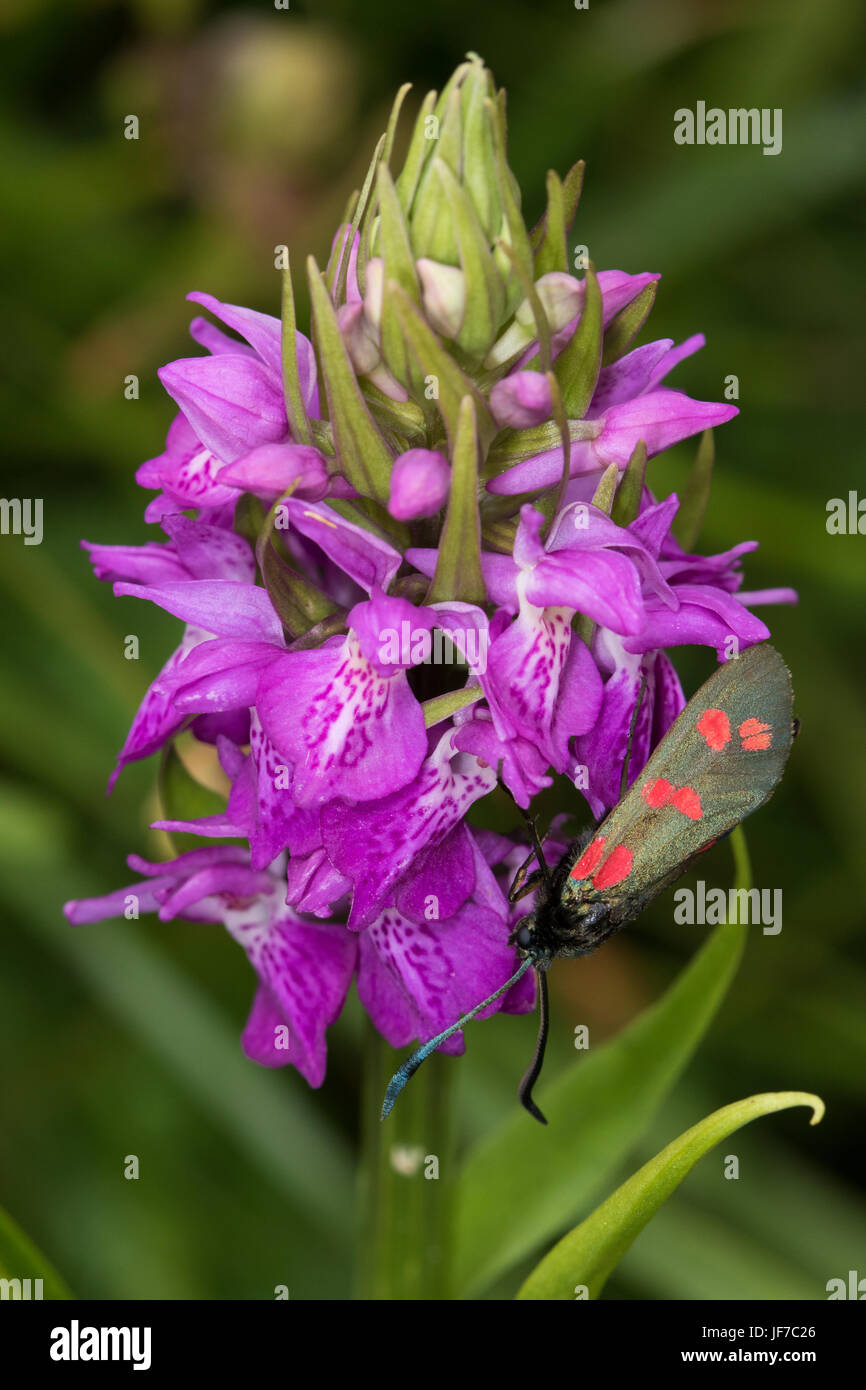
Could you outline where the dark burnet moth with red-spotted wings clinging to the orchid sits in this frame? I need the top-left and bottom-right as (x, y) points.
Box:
(382, 642), (798, 1125)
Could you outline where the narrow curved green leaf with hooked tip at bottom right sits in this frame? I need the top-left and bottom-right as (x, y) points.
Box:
(517, 1091), (824, 1301)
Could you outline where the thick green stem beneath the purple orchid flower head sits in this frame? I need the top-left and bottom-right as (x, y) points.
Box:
(357, 1023), (455, 1301)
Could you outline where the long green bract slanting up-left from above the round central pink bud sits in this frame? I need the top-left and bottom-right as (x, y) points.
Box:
(307, 257), (392, 502)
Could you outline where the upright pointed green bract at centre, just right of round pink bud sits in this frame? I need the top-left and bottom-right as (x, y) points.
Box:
(427, 396), (487, 603)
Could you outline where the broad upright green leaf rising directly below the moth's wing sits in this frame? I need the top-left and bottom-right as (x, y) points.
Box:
(456, 850), (748, 1295)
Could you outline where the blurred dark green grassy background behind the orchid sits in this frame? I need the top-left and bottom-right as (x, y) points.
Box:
(0, 0), (866, 1298)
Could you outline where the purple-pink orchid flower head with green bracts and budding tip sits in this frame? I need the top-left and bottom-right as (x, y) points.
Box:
(67, 57), (792, 1086)
